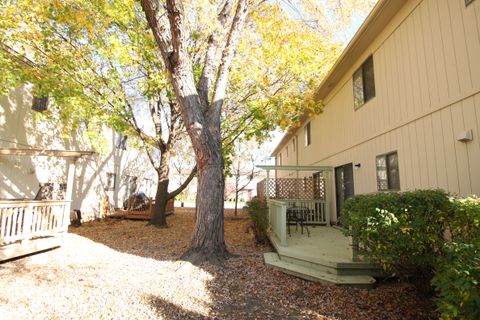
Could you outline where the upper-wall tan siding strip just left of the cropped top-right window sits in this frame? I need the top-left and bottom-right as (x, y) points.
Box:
(447, 1), (474, 91)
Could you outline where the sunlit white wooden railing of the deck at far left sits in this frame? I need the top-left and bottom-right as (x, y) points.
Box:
(0, 200), (70, 245)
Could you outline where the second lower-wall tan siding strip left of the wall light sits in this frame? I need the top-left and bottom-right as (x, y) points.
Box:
(432, 112), (452, 190)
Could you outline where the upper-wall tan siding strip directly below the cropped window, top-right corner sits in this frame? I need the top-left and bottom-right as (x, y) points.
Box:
(461, 0), (480, 88)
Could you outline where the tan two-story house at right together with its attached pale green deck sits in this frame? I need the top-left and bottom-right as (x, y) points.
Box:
(257, 0), (480, 286)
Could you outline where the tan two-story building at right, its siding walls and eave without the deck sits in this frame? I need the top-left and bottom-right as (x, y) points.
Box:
(272, 0), (480, 220)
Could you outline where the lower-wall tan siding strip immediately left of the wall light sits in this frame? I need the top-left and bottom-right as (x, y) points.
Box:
(440, 108), (460, 194)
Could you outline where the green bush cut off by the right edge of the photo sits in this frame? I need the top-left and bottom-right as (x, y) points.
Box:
(432, 197), (480, 320)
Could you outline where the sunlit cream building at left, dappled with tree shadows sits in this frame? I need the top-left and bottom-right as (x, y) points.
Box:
(0, 86), (157, 220)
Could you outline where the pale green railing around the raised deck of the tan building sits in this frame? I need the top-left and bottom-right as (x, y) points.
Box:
(267, 199), (330, 246)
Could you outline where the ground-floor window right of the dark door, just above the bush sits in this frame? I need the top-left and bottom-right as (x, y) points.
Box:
(377, 151), (400, 191)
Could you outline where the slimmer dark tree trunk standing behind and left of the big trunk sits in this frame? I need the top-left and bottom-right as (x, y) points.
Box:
(150, 150), (170, 228)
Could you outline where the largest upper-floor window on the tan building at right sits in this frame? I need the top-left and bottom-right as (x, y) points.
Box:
(353, 56), (375, 109)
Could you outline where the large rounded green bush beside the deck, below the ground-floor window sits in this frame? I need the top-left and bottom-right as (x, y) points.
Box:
(340, 190), (452, 277)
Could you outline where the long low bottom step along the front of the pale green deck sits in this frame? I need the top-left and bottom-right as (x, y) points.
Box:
(264, 252), (375, 287)
